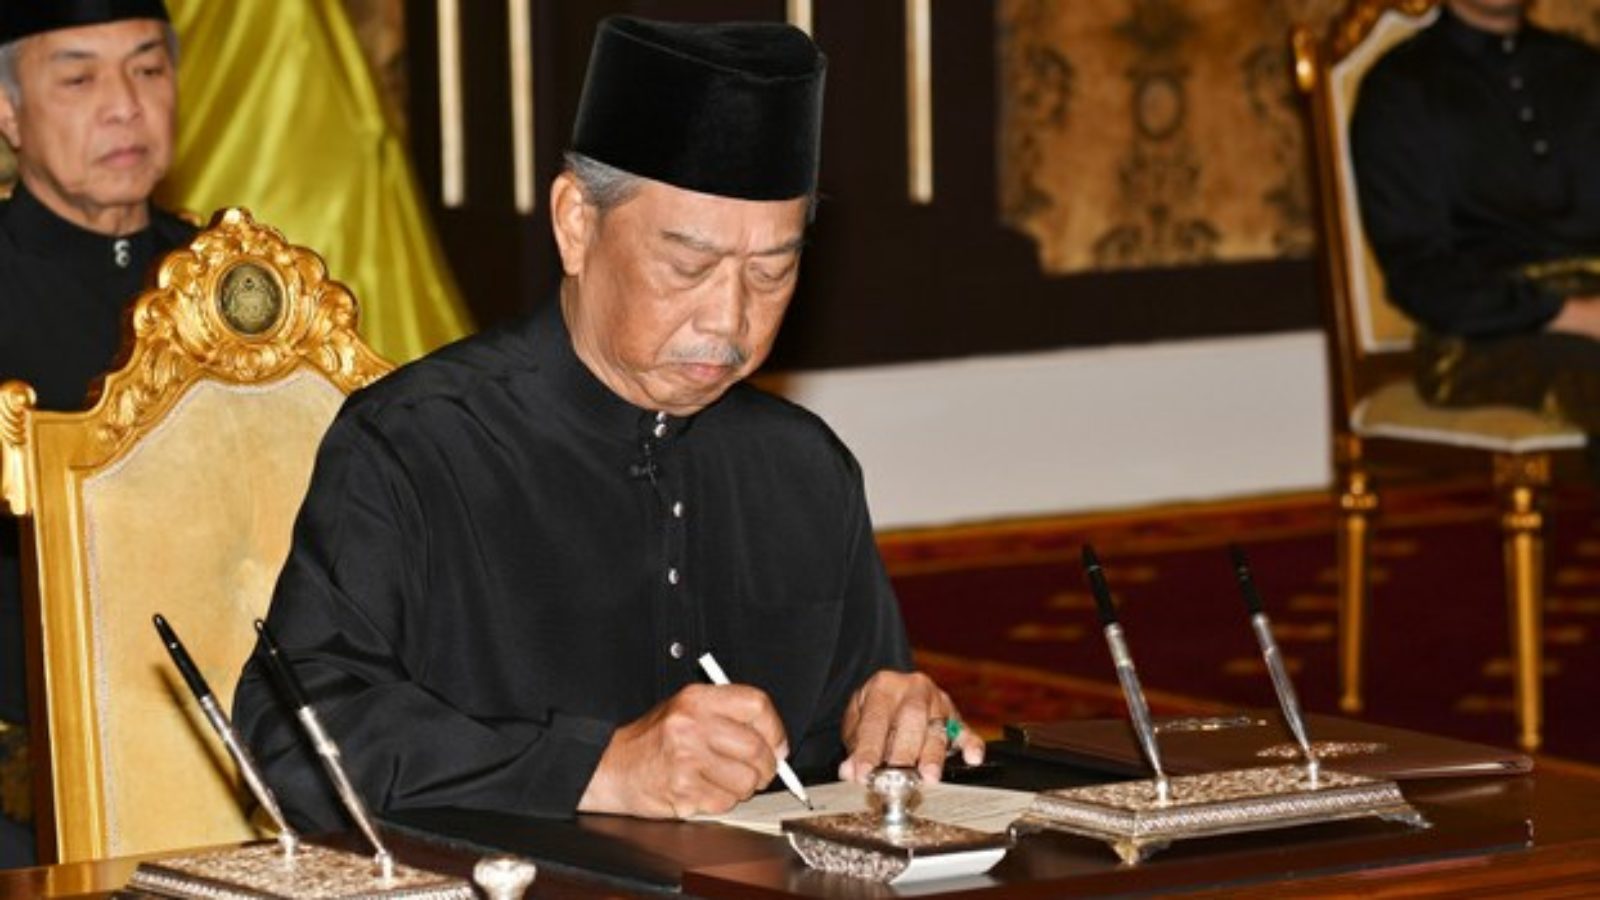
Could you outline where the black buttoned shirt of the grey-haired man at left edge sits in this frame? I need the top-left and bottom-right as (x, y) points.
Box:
(0, 184), (195, 858)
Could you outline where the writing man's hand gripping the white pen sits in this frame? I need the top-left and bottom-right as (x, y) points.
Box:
(578, 684), (789, 818)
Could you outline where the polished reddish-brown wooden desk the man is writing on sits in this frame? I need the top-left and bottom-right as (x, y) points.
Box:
(0, 761), (1600, 900)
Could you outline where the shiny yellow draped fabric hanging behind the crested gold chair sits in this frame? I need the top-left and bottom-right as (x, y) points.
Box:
(160, 0), (470, 362)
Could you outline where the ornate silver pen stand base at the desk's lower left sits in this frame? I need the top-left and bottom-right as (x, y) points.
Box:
(128, 842), (475, 900)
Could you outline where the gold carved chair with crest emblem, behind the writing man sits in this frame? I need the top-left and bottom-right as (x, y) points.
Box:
(0, 210), (389, 862)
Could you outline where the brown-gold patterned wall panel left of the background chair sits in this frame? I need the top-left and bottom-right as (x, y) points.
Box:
(997, 0), (1600, 274)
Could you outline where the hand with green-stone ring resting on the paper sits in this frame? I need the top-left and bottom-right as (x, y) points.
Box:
(838, 669), (984, 781)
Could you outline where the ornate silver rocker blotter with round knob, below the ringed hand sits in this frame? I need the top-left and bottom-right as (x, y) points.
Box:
(782, 767), (1013, 882)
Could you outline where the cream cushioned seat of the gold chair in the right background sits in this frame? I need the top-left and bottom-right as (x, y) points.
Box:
(1350, 381), (1587, 453)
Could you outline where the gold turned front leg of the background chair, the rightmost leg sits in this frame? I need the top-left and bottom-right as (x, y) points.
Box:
(1494, 453), (1550, 753)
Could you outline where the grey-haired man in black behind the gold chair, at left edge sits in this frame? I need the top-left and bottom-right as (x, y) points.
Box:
(0, 0), (194, 866)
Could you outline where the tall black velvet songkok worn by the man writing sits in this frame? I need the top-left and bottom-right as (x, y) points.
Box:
(573, 16), (827, 200)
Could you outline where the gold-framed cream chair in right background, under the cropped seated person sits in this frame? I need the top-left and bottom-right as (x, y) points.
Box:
(1293, 0), (1584, 751)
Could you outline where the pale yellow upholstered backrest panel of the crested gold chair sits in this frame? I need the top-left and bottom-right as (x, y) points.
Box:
(83, 370), (344, 857)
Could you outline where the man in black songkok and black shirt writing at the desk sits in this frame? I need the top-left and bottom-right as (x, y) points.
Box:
(235, 18), (982, 828)
